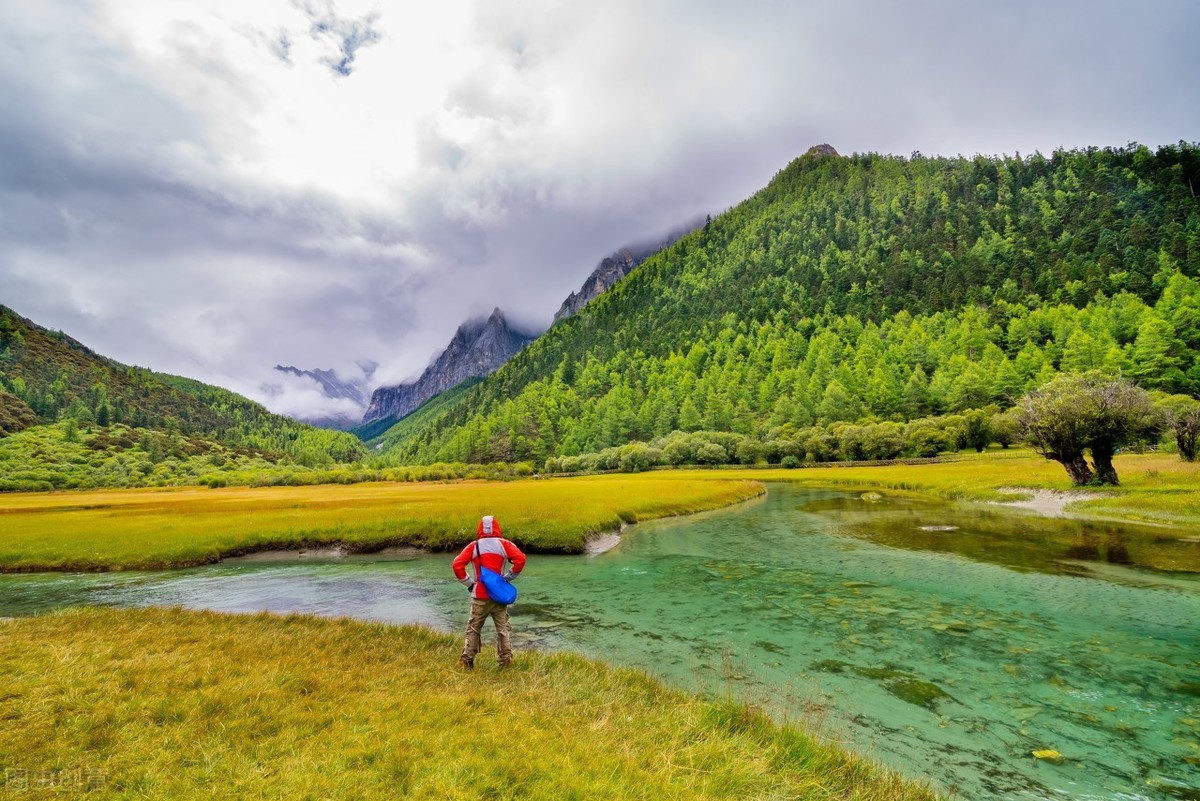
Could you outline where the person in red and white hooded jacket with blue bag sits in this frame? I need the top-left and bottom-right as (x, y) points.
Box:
(451, 514), (526, 669)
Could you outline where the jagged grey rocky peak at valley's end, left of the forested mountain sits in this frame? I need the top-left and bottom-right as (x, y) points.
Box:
(362, 308), (534, 423)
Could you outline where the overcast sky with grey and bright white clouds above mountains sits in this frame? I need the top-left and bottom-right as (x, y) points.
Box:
(0, 0), (1200, 422)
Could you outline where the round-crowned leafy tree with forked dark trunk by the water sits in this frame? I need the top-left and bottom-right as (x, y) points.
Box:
(1018, 371), (1159, 486)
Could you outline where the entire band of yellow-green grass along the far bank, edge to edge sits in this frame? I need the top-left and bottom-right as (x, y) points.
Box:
(0, 450), (1200, 572)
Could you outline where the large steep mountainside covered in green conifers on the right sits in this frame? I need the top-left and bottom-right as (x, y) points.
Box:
(390, 143), (1200, 463)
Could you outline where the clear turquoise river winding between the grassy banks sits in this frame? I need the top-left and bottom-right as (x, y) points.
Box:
(0, 487), (1200, 799)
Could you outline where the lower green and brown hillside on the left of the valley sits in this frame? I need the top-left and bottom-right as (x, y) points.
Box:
(0, 306), (365, 465)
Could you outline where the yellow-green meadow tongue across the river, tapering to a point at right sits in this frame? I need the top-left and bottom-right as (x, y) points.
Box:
(0, 474), (763, 572)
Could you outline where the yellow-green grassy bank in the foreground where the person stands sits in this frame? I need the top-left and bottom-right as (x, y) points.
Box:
(0, 609), (935, 801)
